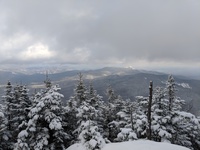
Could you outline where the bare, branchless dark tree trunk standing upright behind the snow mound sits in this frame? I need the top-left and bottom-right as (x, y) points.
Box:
(147, 81), (153, 140)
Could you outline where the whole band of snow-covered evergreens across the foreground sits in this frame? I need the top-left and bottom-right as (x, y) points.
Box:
(0, 73), (200, 150)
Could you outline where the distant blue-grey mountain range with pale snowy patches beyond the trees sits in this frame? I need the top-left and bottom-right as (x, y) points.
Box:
(0, 67), (200, 115)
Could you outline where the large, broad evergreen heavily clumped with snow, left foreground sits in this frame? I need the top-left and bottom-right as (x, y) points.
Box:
(15, 85), (69, 150)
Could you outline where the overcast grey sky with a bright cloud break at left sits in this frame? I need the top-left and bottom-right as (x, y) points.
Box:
(0, 0), (200, 72)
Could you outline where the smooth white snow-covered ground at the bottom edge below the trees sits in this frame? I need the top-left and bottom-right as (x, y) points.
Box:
(67, 140), (189, 150)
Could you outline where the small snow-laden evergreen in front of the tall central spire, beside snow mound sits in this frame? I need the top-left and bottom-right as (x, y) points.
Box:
(77, 99), (105, 150)
